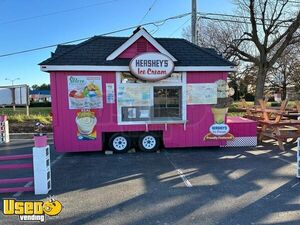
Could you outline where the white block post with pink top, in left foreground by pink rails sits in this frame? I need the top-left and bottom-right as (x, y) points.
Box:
(32, 145), (52, 195)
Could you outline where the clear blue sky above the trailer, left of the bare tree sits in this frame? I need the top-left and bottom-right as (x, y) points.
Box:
(0, 0), (234, 86)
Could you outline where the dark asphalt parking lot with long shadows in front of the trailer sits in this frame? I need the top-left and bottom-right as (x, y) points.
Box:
(0, 141), (300, 225)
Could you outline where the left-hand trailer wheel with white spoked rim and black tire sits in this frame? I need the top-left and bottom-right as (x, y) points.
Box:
(108, 134), (131, 153)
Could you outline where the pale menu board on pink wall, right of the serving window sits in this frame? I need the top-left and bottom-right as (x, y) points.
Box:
(187, 83), (217, 105)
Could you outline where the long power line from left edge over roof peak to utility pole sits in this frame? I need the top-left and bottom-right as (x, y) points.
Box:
(0, 13), (191, 58)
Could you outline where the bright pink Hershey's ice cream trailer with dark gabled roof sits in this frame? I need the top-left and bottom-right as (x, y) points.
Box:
(40, 28), (257, 152)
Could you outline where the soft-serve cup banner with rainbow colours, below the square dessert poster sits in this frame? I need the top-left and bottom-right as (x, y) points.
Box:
(75, 110), (97, 141)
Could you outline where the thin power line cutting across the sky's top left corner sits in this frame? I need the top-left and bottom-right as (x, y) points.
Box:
(0, 0), (120, 25)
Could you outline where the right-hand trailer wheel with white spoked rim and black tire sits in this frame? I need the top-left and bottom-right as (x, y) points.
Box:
(138, 133), (160, 152)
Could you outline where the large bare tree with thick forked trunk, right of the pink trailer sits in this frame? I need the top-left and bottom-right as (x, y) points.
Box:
(230, 0), (300, 101)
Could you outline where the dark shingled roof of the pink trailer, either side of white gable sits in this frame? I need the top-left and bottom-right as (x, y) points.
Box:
(39, 36), (235, 66)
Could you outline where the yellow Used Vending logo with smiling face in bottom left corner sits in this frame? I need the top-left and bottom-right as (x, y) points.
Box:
(3, 198), (63, 222)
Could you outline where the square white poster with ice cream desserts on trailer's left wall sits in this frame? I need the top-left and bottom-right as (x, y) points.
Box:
(68, 76), (103, 109)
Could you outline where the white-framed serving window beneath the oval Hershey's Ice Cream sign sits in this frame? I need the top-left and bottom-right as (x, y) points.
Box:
(117, 72), (186, 124)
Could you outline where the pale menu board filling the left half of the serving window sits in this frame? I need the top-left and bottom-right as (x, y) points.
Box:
(117, 84), (151, 106)
